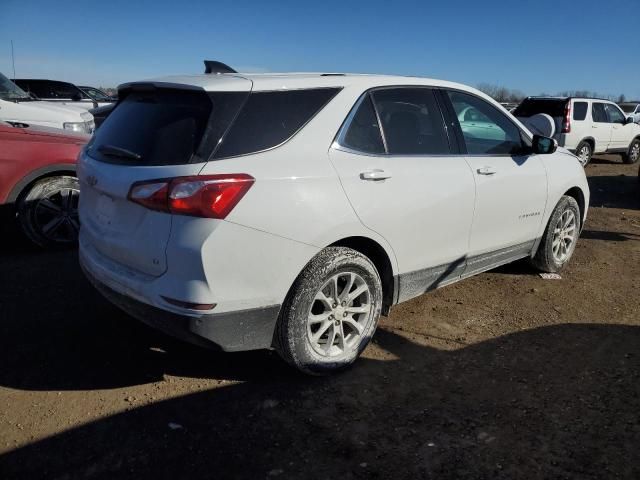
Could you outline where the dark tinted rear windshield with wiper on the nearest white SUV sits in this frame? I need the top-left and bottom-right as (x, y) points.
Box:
(89, 89), (221, 165)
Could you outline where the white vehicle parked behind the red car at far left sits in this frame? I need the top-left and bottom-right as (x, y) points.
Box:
(0, 73), (95, 133)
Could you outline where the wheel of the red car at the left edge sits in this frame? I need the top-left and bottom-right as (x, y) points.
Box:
(18, 175), (80, 247)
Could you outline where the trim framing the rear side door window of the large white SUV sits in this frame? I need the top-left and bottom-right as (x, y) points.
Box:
(331, 85), (459, 158)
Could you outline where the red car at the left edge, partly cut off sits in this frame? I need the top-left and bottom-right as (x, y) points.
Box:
(0, 122), (90, 247)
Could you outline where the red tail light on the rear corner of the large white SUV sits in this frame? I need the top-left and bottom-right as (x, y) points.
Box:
(128, 173), (255, 219)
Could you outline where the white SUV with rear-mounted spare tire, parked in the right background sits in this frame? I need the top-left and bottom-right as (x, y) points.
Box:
(513, 97), (640, 165)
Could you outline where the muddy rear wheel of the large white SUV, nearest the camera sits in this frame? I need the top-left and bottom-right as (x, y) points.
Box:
(276, 247), (382, 375)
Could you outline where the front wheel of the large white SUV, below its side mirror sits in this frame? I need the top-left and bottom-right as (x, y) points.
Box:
(531, 195), (581, 273)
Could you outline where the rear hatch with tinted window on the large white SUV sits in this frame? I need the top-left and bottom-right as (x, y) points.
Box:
(78, 77), (252, 276)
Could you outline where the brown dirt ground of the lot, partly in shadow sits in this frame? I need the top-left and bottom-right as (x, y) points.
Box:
(0, 157), (640, 480)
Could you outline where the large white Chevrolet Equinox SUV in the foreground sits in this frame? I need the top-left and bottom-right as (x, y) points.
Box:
(78, 74), (589, 374)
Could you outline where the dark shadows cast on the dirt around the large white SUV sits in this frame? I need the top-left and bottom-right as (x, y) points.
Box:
(0, 251), (640, 479)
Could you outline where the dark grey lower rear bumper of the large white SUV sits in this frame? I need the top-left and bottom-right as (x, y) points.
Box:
(80, 257), (280, 352)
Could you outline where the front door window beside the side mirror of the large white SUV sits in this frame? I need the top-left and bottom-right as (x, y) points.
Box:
(447, 91), (522, 155)
